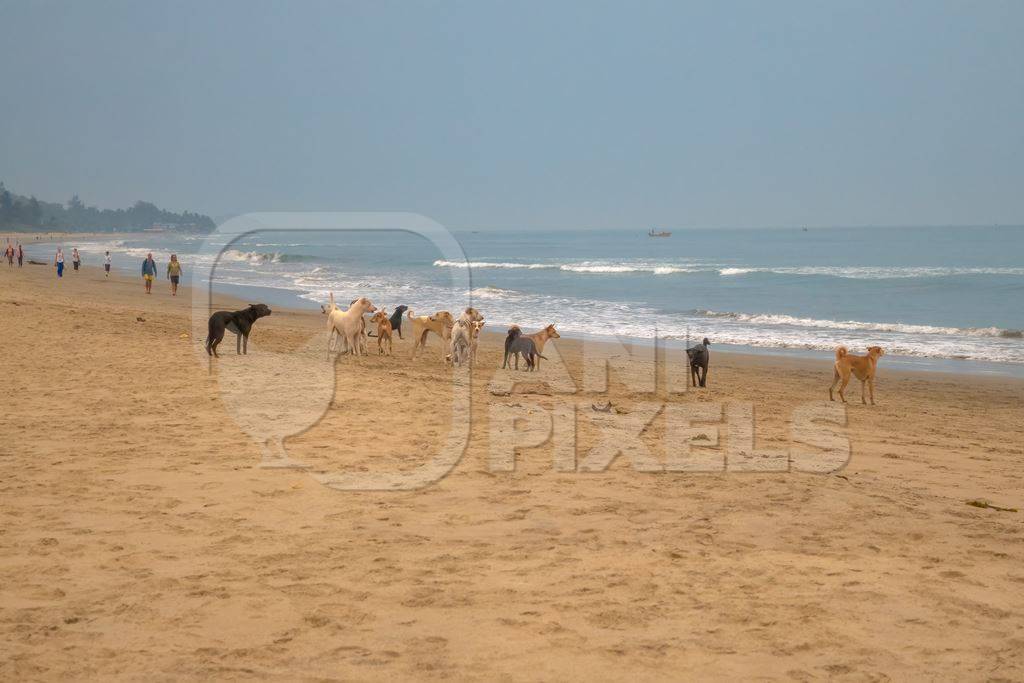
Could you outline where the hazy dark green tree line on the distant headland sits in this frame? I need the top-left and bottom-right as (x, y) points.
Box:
(0, 182), (216, 232)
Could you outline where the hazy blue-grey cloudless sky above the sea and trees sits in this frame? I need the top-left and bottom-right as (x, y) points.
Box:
(0, 0), (1024, 228)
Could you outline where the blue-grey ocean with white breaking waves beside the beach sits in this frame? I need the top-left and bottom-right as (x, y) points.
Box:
(29, 226), (1024, 375)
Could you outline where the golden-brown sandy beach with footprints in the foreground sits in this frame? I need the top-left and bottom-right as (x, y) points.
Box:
(0, 264), (1024, 680)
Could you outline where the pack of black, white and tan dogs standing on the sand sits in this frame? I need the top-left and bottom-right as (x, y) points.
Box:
(206, 292), (885, 405)
